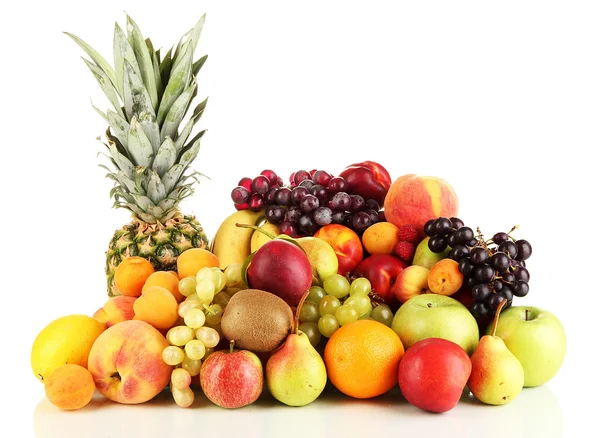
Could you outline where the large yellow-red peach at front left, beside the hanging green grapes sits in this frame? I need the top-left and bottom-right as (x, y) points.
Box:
(88, 318), (173, 404)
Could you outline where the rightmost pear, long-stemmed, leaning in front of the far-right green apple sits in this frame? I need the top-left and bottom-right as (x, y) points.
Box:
(467, 300), (525, 405)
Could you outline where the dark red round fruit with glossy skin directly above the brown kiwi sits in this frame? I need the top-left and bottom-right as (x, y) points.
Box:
(247, 239), (313, 306)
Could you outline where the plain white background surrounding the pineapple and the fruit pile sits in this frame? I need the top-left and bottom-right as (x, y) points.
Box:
(0, 0), (600, 437)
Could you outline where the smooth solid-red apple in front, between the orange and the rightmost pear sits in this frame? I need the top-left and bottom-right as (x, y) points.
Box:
(398, 338), (472, 412)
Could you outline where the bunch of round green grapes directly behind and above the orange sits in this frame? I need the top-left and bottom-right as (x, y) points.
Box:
(299, 274), (394, 346)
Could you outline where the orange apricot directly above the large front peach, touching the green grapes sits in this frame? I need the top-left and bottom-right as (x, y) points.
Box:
(133, 286), (179, 330)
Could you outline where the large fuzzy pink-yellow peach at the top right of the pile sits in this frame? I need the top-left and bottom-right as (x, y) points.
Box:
(383, 174), (458, 239)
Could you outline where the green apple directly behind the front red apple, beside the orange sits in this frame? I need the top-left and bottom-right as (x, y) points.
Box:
(392, 293), (479, 356)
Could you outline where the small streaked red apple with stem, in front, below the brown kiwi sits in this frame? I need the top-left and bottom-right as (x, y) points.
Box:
(200, 342), (264, 409)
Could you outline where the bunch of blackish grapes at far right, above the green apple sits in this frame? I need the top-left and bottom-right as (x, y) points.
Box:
(424, 217), (532, 318)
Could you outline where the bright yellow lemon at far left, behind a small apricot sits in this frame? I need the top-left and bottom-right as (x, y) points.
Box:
(31, 315), (105, 382)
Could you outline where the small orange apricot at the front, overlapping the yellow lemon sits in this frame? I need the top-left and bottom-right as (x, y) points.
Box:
(44, 364), (96, 411)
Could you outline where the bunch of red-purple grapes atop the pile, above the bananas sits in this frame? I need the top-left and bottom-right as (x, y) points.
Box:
(231, 170), (383, 237)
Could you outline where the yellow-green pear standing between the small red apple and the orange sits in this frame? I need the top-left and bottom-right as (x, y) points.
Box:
(265, 330), (327, 406)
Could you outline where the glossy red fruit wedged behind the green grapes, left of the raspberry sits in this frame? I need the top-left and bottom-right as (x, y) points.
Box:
(355, 254), (407, 305)
